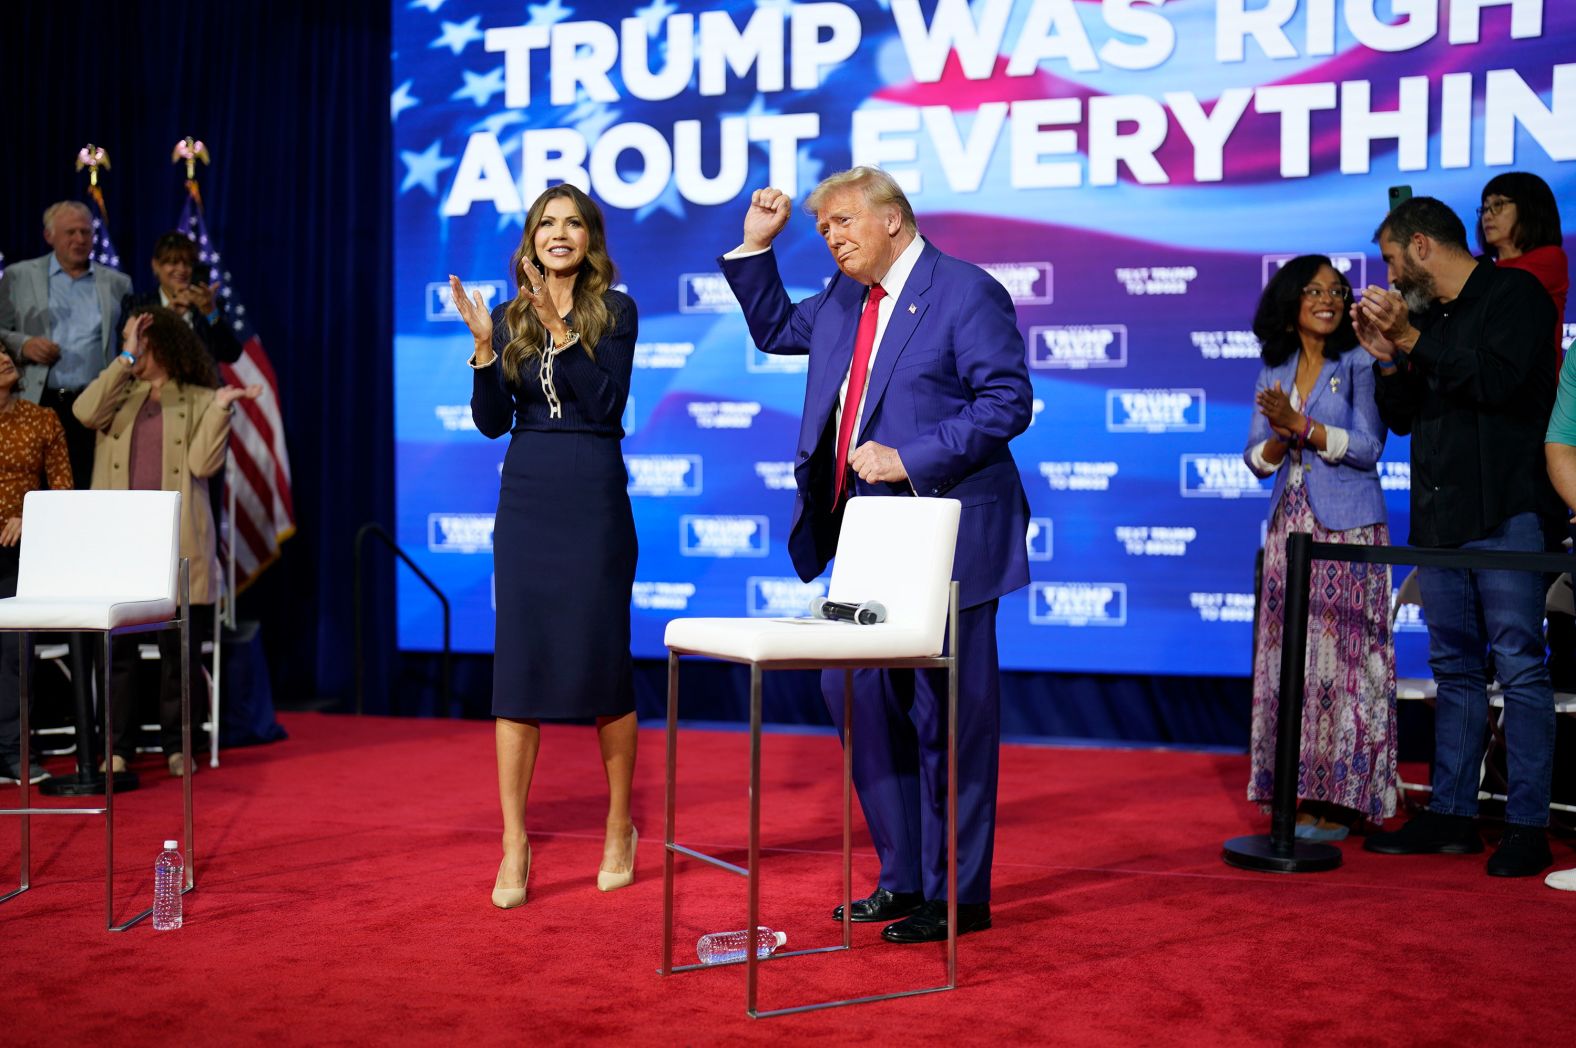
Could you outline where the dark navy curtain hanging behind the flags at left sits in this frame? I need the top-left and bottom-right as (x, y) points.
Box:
(0, 0), (392, 704)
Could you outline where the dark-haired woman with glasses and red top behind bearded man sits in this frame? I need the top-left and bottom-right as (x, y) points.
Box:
(1477, 172), (1571, 364)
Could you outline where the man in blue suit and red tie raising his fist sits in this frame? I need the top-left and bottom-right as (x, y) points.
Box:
(720, 167), (1032, 942)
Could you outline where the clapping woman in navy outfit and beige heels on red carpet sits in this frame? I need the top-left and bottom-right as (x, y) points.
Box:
(449, 186), (637, 909)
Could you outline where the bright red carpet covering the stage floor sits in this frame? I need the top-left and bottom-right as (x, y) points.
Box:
(0, 714), (1576, 1045)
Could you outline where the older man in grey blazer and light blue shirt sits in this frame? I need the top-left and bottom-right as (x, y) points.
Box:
(0, 200), (131, 487)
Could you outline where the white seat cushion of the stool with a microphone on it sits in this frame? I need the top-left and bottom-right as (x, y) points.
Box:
(662, 618), (941, 665)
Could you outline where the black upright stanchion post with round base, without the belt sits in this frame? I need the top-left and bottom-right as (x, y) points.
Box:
(1220, 531), (1341, 873)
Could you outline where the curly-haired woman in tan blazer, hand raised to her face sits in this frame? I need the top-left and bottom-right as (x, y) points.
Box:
(71, 307), (262, 775)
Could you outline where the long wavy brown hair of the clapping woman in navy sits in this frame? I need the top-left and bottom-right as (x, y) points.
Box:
(503, 183), (618, 383)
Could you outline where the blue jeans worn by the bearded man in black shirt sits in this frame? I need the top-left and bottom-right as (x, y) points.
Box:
(1417, 514), (1554, 826)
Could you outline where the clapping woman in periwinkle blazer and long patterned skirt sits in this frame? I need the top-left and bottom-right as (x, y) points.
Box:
(1242, 255), (1396, 840)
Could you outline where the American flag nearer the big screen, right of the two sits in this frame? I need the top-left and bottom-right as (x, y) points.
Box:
(177, 188), (295, 593)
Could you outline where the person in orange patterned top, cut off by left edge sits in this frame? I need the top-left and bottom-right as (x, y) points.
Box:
(0, 351), (71, 782)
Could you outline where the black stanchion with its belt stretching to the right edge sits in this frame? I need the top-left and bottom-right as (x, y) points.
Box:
(1221, 531), (1576, 873)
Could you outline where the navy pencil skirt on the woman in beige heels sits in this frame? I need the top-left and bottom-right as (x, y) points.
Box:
(493, 430), (637, 720)
